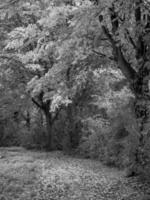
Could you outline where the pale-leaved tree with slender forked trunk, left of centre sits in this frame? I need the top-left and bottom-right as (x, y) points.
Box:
(1, 1), (79, 149)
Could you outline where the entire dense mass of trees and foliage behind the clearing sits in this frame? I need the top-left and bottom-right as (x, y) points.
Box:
(0, 0), (150, 181)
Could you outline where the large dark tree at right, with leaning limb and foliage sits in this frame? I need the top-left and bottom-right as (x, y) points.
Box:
(94, 0), (150, 173)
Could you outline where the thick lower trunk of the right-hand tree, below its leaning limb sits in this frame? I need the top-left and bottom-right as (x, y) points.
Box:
(133, 68), (150, 174)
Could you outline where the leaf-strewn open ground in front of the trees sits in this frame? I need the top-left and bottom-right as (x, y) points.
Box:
(0, 148), (149, 200)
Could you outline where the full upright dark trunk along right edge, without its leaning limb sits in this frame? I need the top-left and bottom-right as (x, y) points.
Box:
(129, 0), (150, 172)
